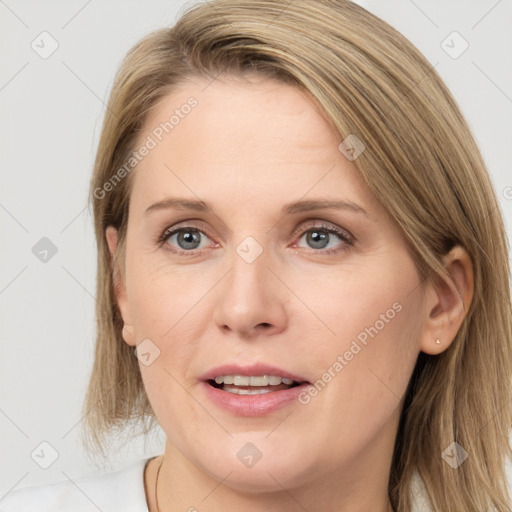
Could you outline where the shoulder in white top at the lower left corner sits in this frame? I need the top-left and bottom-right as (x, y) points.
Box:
(0, 459), (149, 512)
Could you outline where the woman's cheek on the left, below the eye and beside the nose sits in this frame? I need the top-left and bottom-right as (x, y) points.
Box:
(123, 258), (215, 416)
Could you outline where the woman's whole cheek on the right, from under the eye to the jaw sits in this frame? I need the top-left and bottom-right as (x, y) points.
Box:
(301, 259), (424, 456)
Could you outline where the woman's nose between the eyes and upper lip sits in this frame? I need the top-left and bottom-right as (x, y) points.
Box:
(213, 238), (290, 338)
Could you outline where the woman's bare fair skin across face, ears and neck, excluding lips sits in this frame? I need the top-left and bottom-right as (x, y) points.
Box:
(106, 73), (473, 512)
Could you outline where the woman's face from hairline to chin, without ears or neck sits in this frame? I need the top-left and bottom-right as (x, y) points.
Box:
(112, 75), (425, 492)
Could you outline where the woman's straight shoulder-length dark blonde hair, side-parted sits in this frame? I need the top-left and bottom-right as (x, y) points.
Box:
(84, 0), (512, 512)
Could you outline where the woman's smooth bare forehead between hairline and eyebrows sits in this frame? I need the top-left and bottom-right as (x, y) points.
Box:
(125, 79), (368, 217)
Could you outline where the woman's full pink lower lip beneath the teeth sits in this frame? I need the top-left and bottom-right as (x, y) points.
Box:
(202, 382), (309, 416)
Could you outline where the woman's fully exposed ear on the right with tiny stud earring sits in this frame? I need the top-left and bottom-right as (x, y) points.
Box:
(421, 245), (474, 355)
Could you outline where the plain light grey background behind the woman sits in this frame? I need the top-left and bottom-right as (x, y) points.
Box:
(0, 0), (512, 497)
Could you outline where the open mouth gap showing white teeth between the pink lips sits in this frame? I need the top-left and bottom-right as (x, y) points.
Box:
(207, 375), (308, 395)
